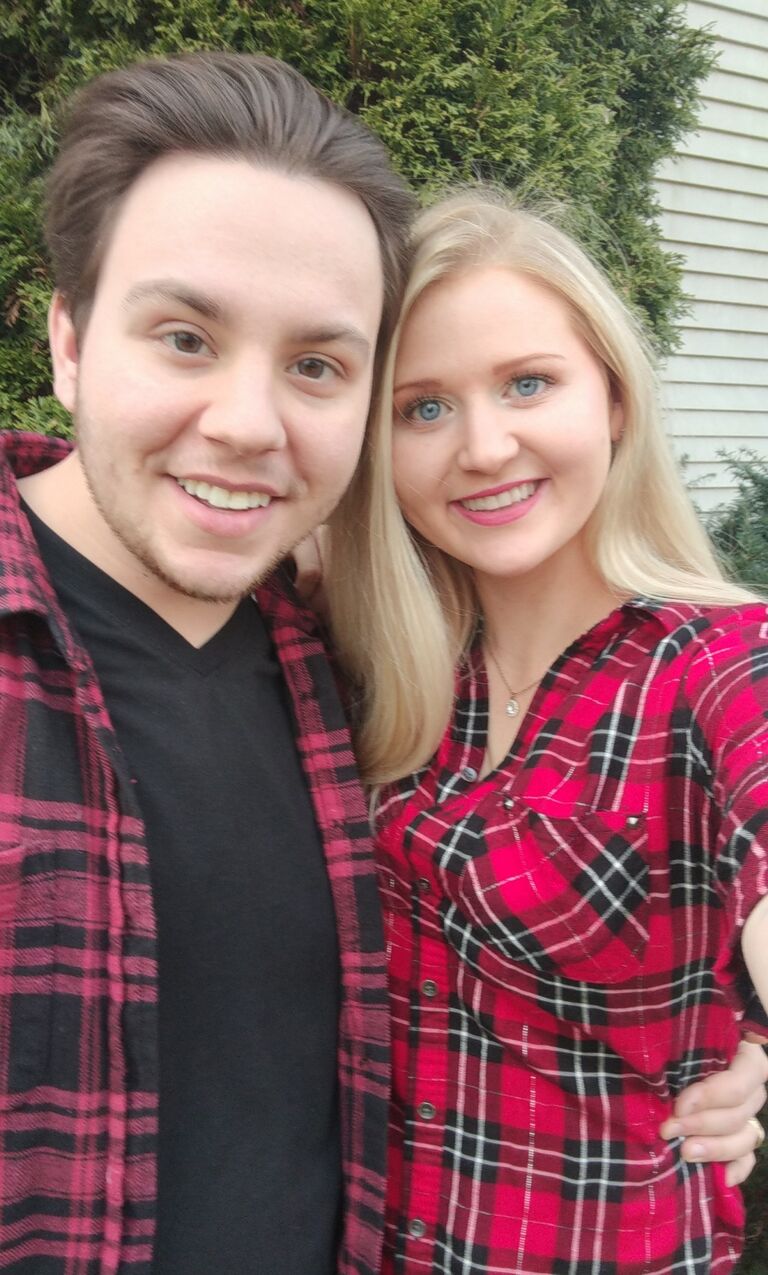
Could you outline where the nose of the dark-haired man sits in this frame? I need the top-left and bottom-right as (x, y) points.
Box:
(199, 361), (287, 454)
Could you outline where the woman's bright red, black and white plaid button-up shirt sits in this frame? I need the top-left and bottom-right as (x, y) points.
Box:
(379, 599), (768, 1275)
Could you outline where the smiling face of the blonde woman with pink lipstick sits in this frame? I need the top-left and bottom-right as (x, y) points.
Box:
(393, 266), (623, 591)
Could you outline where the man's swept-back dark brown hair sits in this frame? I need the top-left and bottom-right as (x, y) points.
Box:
(46, 52), (413, 340)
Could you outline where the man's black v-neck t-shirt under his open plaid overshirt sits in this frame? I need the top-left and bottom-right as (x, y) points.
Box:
(27, 510), (341, 1275)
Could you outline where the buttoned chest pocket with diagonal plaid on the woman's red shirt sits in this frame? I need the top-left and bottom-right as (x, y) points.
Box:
(457, 808), (649, 983)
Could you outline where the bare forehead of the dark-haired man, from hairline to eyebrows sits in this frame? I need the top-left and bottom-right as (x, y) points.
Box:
(95, 156), (383, 318)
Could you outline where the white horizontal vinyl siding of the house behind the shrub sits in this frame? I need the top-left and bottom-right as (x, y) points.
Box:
(657, 0), (768, 511)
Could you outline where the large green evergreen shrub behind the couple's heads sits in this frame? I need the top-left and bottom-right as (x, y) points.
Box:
(0, 0), (711, 431)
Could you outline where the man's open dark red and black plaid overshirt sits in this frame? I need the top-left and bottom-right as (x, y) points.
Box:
(0, 434), (388, 1275)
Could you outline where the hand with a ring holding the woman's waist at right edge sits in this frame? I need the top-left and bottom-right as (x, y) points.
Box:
(660, 1040), (768, 1186)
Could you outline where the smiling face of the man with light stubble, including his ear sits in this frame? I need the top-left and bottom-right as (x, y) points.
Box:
(50, 154), (383, 602)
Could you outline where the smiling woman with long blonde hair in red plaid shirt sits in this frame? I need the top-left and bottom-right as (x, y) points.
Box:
(328, 193), (768, 1275)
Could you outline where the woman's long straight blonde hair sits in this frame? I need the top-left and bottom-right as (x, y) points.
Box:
(322, 187), (753, 784)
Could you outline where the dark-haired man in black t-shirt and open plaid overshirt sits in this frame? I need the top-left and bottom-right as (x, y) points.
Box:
(0, 47), (751, 1275)
